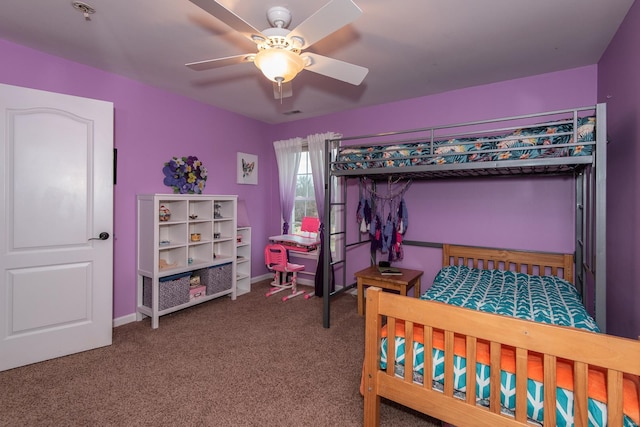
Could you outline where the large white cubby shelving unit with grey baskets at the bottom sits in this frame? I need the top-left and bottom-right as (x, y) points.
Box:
(137, 194), (237, 328)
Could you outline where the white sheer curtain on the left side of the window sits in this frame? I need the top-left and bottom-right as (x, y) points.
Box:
(273, 138), (302, 234)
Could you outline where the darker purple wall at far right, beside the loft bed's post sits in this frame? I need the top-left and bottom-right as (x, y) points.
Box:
(598, 2), (640, 338)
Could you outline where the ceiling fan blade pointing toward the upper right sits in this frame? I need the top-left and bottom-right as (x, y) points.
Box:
(288, 0), (362, 49)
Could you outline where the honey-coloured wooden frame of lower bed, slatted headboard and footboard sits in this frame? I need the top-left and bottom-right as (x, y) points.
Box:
(363, 245), (640, 427)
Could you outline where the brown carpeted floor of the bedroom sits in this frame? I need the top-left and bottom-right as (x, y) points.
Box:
(0, 282), (440, 426)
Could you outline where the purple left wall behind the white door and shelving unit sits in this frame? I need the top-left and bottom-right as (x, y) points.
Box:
(0, 40), (278, 318)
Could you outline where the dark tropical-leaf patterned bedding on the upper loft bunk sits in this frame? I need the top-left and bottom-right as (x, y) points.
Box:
(333, 116), (596, 170)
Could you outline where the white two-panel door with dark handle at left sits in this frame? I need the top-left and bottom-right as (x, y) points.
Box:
(0, 84), (113, 371)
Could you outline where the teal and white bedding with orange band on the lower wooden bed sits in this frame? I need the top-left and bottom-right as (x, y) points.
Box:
(381, 266), (640, 427)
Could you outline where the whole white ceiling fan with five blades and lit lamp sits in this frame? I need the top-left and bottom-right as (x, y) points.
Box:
(186, 0), (369, 100)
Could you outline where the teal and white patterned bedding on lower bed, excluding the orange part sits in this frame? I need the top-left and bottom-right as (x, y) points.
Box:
(380, 266), (636, 427)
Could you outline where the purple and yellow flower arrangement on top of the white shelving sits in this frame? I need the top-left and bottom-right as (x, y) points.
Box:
(162, 156), (207, 194)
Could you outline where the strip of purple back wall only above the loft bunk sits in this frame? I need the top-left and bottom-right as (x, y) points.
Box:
(275, 65), (597, 139)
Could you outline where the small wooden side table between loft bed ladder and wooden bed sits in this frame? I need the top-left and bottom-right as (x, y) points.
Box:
(355, 265), (423, 316)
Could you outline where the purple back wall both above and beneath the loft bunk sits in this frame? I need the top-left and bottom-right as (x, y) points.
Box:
(277, 65), (597, 298)
